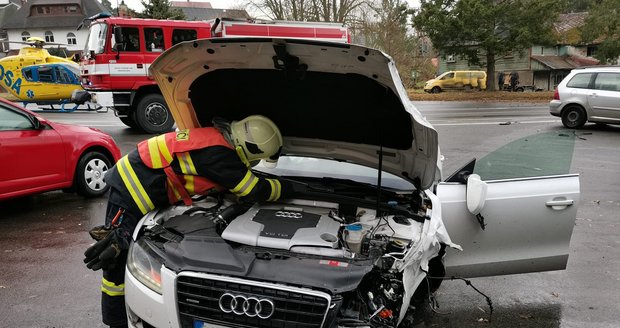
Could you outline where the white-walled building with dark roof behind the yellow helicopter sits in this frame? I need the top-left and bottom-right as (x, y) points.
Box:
(2, 0), (107, 56)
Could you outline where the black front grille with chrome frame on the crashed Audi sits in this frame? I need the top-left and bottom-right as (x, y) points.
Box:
(177, 274), (331, 328)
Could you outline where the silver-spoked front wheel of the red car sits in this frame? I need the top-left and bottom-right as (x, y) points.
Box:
(74, 151), (112, 197)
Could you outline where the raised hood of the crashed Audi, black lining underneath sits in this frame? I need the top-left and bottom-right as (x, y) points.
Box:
(150, 38), (439, 188)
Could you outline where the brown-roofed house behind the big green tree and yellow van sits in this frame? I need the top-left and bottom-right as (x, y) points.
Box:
(439, 12), (599, 90)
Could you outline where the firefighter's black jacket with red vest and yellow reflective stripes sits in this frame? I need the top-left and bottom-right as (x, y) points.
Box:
(106, 127), (289, 214)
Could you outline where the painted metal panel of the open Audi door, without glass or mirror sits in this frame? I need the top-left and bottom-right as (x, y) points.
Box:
(437, 170), (579, 278)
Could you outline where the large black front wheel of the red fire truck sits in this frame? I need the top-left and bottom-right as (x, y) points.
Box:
(136, 94), (174, 134)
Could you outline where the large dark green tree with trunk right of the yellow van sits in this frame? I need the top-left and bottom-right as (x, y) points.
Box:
(413, 0), (562, 91)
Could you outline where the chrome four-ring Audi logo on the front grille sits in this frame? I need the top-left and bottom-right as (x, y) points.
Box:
(218, 293), (276, 319)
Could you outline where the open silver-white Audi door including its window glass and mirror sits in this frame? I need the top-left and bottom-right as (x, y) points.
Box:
(437, 121), (579, 277)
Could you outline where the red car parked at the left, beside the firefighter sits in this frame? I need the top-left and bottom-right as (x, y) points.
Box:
(0, 98), (121, 200)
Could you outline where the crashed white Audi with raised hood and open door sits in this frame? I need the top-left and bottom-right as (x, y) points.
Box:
(125, 39), (579, 328)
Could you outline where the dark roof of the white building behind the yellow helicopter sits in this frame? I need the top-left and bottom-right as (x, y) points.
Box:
(4, 0), (107, 29)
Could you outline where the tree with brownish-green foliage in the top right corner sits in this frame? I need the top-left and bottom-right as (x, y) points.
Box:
(581, 0), (620, 64)
